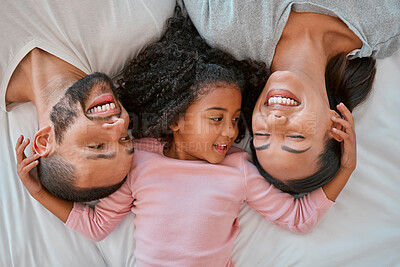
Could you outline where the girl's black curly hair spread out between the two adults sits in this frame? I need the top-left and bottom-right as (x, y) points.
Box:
(117, 7), (267, 147)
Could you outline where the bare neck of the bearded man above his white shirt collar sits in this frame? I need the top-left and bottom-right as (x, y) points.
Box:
(6, 48), (86, 122)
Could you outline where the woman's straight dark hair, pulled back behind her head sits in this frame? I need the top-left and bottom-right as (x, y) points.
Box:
(250, 53), (376, 194)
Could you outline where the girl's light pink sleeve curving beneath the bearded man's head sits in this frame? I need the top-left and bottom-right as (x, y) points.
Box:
(65, 179), (133, 241)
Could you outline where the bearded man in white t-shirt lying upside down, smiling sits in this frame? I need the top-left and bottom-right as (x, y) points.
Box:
(0, 0), (175, 201)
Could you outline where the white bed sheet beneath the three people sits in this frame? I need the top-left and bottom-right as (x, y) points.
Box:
(0, 52), (400, 267)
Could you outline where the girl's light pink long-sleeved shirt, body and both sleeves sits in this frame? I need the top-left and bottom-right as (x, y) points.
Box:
(66, 139), (333, 267)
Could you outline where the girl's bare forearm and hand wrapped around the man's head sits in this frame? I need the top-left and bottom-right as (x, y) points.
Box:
(15, 135), (74, 223)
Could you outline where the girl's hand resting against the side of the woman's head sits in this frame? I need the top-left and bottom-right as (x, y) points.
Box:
(332, 103), (357, 173)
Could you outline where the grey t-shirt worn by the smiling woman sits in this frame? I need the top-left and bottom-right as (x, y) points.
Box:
(184, 0), (400, 66)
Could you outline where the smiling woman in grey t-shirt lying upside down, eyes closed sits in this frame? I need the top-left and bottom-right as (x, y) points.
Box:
(185, 0), (400, 196)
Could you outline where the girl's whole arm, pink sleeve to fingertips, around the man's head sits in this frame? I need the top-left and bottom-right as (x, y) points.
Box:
(16, 136), (133, 241)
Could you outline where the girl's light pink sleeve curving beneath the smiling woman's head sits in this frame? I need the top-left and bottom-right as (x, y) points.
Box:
(243, 157), (334, 233)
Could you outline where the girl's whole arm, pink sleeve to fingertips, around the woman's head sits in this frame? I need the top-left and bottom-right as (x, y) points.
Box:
(245, 104), (356, 233)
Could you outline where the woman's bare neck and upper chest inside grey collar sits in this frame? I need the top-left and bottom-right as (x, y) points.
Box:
(271, 11), (362, 76)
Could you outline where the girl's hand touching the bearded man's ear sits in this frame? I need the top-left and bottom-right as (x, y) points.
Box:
(15, 135), (43, 196)
